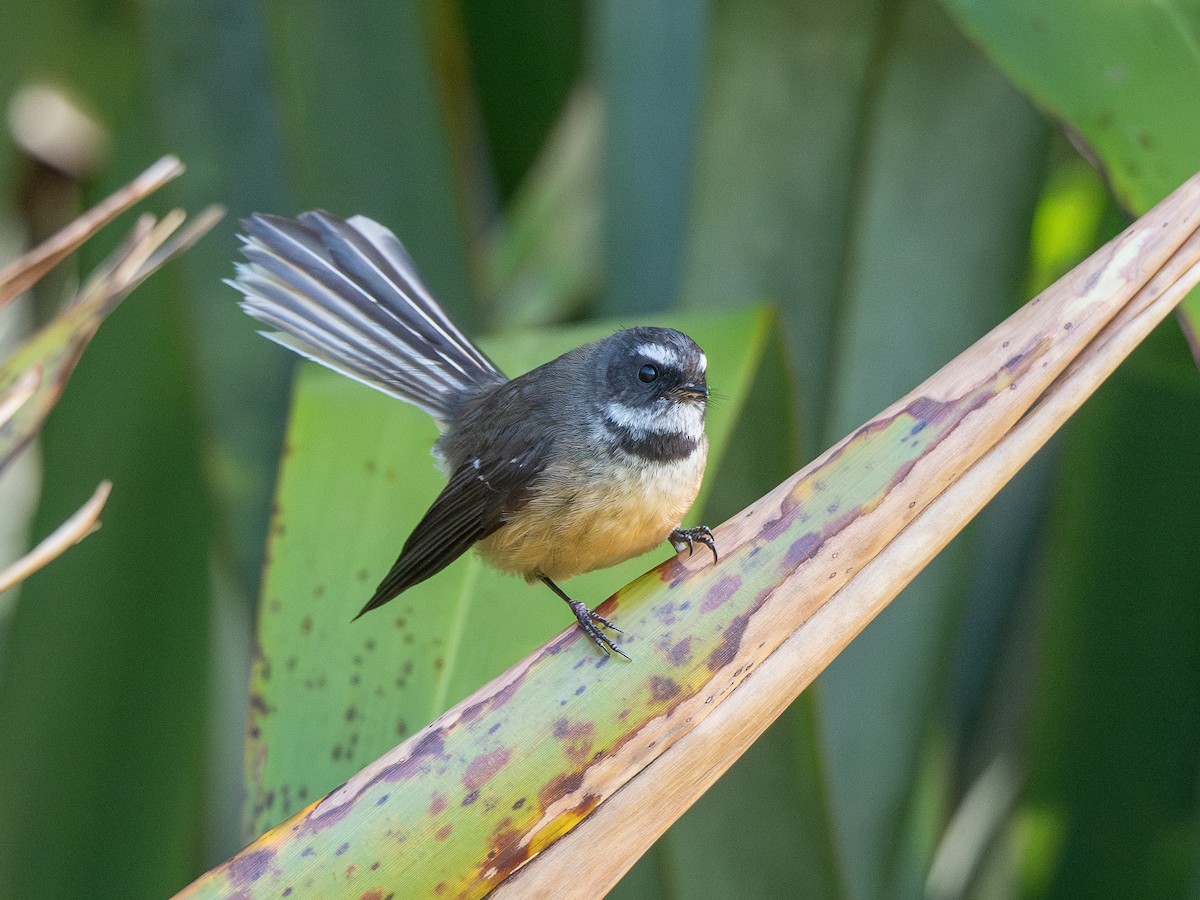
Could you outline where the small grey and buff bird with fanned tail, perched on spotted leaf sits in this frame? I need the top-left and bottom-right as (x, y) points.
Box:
(228, 211), (716, 659)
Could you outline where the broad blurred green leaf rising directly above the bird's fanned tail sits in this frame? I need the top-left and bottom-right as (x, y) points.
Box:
(266, 0), (481, 328)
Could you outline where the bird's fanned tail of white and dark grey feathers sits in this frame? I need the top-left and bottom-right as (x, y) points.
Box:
(227, 211), (506, 424)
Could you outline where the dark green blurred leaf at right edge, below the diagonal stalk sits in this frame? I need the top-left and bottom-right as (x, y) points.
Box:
(1024, 328), (1200, 900)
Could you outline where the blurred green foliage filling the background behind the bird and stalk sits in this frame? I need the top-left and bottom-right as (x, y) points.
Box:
(0, 0), (1200, 900)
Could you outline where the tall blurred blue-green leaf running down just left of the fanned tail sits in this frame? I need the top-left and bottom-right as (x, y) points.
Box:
(140, 0), (297, 859)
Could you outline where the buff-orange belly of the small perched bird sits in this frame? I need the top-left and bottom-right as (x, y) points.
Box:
(478, 442), (707, 581)
